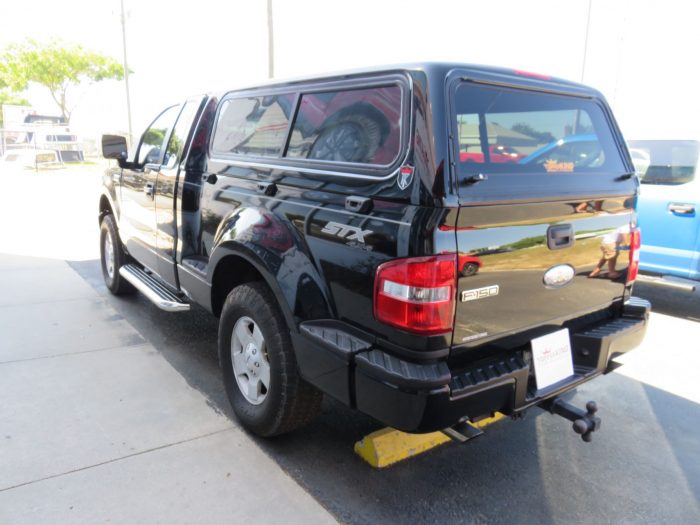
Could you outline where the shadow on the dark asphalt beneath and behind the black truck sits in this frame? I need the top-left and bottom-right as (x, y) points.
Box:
(70, 261), (700, 524)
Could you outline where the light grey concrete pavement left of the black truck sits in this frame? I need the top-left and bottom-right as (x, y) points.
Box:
(0, 254), (335, 524)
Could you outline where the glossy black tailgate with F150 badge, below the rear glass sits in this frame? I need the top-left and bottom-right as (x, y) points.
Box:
(453, 198), (633, 346)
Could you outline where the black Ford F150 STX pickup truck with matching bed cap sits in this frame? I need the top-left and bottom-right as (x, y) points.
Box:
(99, 63), (650, 441)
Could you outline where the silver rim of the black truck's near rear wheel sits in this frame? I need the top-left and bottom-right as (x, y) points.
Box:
(231, 317), (270, 405)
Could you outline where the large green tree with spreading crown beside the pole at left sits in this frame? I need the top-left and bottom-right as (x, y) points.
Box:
(0, 40), (124, 120)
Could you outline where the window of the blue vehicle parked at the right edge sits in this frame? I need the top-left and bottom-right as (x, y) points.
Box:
(628, 140), (700, 185)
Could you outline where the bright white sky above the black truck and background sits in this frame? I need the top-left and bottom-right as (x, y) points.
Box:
(0, 0), (700, 138)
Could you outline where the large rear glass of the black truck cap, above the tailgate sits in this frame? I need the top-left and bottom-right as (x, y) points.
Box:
(455, 83), (624, 174)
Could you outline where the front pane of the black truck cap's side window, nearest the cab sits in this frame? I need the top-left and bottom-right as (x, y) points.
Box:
(213, 95), (294, 157)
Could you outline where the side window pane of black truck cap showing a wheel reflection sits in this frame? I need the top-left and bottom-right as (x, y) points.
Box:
(287, 86), (401, 165)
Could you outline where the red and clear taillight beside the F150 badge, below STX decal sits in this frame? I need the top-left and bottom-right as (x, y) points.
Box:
(374, 254), (457, 335)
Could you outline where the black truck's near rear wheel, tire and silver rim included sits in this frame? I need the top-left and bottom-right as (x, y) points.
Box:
(219, 282), (323, 437)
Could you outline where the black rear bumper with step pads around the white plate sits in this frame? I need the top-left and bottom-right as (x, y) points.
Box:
(294, 298), (650, 432)
